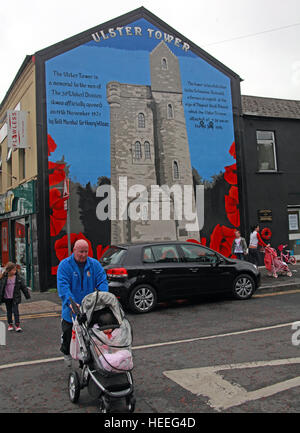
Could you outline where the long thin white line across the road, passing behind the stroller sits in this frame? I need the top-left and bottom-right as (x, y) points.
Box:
(0, 321), (295, 370)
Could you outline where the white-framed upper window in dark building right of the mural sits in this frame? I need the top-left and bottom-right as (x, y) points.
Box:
(256, 131), (277, 171)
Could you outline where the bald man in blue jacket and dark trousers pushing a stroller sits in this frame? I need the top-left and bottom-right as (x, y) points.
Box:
(57, 239), (108, 366)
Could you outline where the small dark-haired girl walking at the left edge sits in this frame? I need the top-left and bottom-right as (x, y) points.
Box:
(0, 262), (30, 332)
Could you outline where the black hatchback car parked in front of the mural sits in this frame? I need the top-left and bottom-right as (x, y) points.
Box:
(100, 241), (260, 313)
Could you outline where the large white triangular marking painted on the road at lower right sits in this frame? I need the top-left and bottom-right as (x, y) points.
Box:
(163, 358), (300, 412)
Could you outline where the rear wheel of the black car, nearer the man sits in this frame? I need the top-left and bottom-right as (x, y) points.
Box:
(128, 284), (157, 313)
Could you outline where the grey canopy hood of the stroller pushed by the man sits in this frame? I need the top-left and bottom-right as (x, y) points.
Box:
(81, 290), (125, 326)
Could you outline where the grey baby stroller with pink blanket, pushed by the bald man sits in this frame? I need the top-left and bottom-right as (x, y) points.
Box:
(68, 290), (135, 413)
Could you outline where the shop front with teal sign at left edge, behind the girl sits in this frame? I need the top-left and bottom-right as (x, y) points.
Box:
(0, 180), (37, 290)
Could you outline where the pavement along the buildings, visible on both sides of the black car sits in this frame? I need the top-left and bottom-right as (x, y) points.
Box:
(0, 263), (300, 320)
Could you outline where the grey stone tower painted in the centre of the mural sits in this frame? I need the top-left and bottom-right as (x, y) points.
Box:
(107, 41), (199, 243)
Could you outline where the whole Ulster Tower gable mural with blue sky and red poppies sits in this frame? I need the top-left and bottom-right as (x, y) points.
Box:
(36, 8), (241, 286)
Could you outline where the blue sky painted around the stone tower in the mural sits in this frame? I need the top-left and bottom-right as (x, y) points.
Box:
(46, 19), (234, 185)
